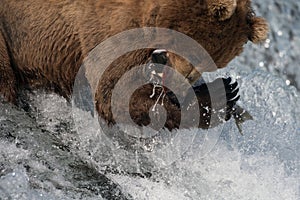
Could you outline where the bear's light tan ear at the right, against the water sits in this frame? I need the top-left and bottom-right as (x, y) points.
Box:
(249, 17), (269, 44)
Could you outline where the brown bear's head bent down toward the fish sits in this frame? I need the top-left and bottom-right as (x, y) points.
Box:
(144, 0), (269, 83)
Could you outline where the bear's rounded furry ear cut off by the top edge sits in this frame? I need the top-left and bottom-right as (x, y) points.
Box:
(206, 0), (237, 21)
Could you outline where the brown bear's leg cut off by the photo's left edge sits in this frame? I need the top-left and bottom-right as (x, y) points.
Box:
(0, 31), (16, 103)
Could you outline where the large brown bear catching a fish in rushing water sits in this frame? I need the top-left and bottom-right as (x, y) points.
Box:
(0, 0), (268, 129)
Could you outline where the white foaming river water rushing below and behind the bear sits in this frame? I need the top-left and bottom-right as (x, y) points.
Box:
(0, 0), (300, 200)
